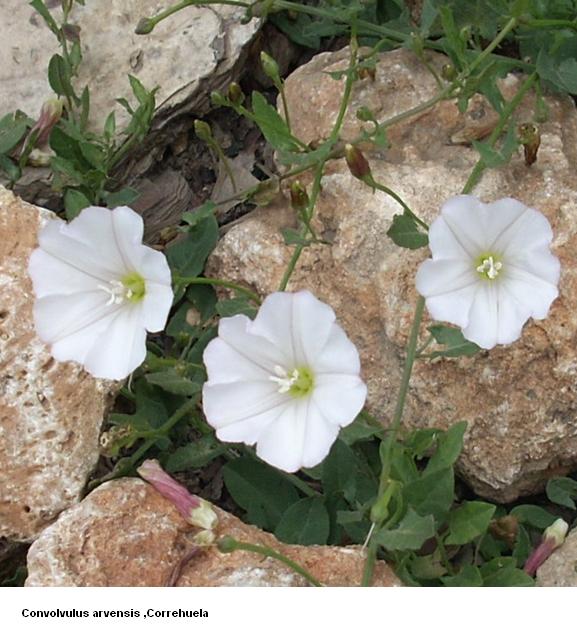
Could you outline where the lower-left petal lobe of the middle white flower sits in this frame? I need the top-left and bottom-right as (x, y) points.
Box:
(202, 380), (292, 429)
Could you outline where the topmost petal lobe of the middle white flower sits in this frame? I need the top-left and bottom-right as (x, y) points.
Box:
(251, 290), (335, 368)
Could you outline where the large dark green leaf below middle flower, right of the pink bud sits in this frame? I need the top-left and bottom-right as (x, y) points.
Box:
(223, 458), (299, 530)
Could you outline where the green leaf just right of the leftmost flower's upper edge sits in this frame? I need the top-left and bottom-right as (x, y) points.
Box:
(166, 215), (218, 277)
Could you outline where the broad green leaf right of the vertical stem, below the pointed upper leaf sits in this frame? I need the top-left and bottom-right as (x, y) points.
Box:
(403, 468), (455, 522)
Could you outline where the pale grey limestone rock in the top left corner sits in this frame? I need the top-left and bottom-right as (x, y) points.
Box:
(0, 0), (259, 130)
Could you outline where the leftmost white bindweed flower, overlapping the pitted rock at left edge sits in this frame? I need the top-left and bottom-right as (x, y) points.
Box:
(28, 207), (173, 379)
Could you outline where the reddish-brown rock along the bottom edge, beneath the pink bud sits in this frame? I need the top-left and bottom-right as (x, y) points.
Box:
(26, 478), (400, 587)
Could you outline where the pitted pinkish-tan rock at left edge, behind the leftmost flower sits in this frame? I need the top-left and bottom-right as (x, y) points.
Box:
(0, 186), (109, 541)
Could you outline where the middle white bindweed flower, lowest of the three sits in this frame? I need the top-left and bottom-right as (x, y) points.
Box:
(203, 291), (367, 472)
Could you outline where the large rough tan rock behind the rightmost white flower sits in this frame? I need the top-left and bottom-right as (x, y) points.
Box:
(209, 50), (577, 502)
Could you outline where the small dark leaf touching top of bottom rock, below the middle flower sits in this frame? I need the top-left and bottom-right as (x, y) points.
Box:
(274, 497), (330, 545)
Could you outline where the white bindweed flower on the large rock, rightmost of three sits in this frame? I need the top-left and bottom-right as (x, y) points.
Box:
(416, 195), (560, 349)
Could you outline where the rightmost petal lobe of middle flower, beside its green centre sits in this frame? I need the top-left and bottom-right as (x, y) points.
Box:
(312, 374), (367, 427)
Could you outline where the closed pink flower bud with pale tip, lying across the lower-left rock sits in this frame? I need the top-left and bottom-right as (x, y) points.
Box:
(137, 460), (217, 530)
